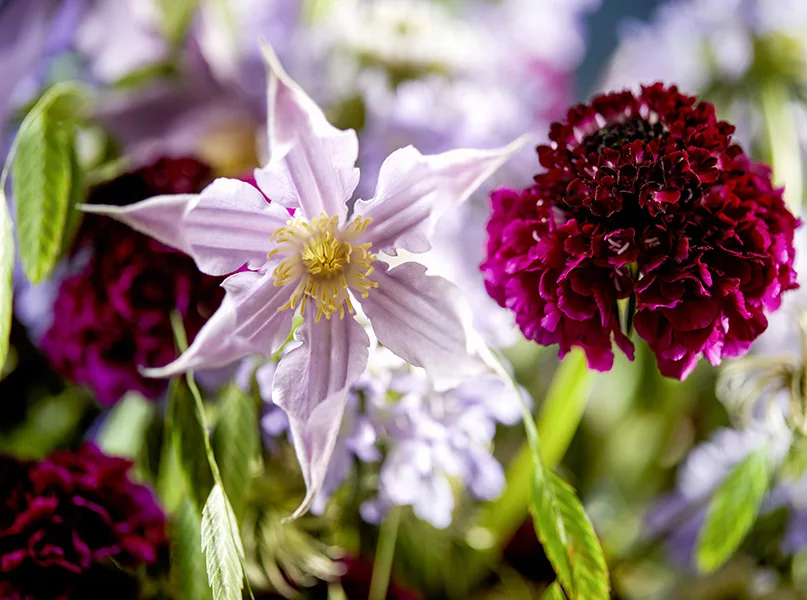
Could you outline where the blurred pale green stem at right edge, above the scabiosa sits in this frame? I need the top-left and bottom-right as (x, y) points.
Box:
(760, 79), (804, 213)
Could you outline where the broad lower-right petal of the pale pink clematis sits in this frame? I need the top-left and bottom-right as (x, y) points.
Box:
(361, 262), (485, 387)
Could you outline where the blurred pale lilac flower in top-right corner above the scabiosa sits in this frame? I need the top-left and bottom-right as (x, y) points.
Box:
(600, 0), (807, 146)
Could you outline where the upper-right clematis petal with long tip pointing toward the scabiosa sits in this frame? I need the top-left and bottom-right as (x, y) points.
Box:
(356, 138), (525, 253)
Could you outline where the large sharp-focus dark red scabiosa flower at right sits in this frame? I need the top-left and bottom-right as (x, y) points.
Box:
(482, 83), (799, 379)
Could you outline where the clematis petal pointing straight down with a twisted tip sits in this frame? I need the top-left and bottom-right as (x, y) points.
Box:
(272, 304), (370, 518)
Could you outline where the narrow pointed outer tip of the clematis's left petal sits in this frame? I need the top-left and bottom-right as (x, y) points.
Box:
(78, 194), (196, 254)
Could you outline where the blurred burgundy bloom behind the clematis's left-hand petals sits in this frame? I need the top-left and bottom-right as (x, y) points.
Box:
(42, 158), (223, 404)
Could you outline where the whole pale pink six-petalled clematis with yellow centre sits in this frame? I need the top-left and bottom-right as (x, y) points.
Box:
(83, 48), (521, 516)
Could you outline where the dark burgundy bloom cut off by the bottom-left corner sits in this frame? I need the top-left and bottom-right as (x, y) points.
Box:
(0, 444), (167, 600)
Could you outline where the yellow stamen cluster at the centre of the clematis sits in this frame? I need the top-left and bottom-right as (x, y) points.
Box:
(269, 213), (378, 322)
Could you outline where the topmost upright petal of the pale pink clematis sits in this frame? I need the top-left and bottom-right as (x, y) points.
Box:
(255, 46), (359, 220)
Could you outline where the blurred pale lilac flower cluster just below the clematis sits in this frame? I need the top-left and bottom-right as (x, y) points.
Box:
(256, 347), (521, 528)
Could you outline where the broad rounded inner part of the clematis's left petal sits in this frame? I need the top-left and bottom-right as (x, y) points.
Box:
(183, 178), (291, 275)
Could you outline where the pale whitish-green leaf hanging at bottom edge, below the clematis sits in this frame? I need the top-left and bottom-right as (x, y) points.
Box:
(202, 484), (244, 600)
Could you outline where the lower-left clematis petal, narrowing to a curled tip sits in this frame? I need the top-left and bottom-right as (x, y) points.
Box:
(143, 270), (292, 377)
